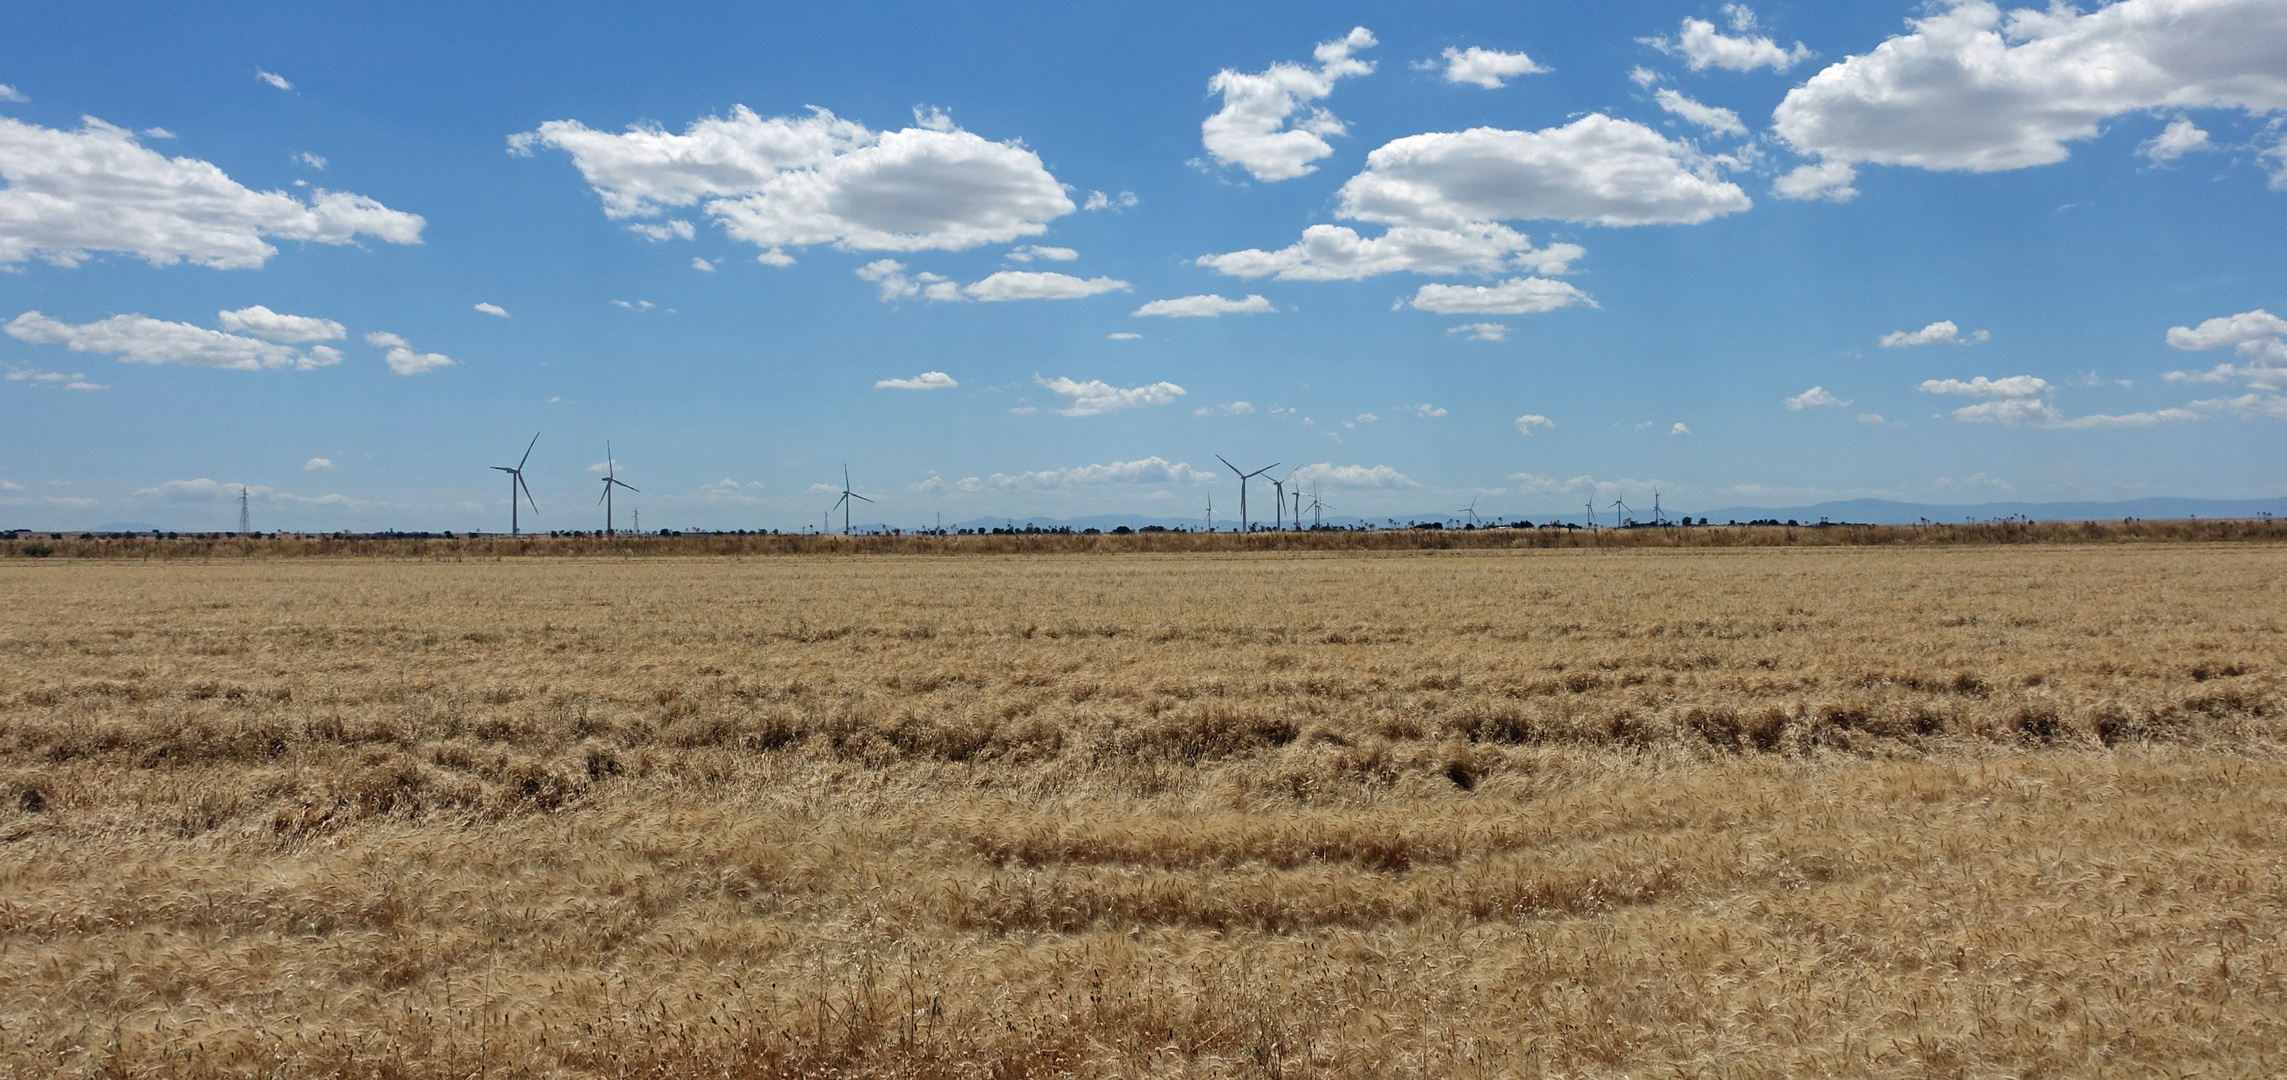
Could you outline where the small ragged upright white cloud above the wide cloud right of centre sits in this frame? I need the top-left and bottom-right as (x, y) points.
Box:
(1198, 25), (1374, 181)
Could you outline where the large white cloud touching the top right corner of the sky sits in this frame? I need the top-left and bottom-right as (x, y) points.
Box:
(1772, 0), (2287, 172)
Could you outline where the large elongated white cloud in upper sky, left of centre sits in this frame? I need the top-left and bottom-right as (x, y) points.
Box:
(508, 105), (1075, 259)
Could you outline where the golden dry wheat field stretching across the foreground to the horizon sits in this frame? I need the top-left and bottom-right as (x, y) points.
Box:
(0, 542), (2287, 1078)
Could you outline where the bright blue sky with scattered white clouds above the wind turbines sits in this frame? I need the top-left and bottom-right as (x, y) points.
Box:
(0, 0), (2287, 529)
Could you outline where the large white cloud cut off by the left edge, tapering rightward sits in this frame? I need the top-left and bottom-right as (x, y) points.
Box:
(0, 117), (425, 270)
